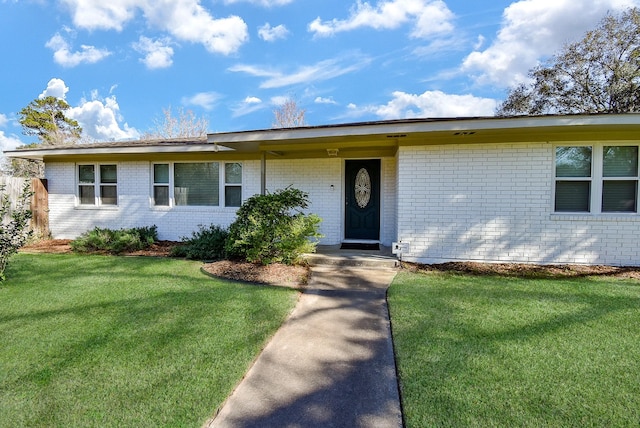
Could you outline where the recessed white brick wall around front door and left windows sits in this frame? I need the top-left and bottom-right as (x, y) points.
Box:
(46, 158), (396, 245)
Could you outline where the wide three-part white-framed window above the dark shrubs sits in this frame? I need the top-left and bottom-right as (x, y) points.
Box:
(153, 162), (242, 207)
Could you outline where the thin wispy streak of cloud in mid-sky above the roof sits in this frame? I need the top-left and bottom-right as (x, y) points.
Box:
(229, 55), (371, 89)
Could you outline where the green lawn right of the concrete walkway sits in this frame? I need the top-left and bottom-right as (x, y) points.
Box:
(389, 273), (640, 428)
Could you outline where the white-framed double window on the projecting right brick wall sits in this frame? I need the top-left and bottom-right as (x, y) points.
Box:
(554, 145), (639, 213)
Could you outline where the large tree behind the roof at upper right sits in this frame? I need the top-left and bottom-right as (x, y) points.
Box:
(496, 8), (640, 116)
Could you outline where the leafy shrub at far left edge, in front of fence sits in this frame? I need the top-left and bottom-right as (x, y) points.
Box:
(0, 182), (33, 281)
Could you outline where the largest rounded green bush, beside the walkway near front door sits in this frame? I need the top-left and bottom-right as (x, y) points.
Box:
(226, 188), (322, 265)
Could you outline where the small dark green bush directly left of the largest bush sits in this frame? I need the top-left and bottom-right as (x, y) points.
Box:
(171, 224), (229, 260)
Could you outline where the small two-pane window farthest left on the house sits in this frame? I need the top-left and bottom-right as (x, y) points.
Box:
(78, 165), (118, 205)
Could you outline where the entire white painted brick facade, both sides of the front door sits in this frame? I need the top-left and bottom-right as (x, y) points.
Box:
(46, 143), (640, 265)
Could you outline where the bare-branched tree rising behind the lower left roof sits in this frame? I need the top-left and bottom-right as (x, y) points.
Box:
(142, 106), (209, 139)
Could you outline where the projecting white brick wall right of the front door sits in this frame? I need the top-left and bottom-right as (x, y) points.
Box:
(398, 143), (640, 265)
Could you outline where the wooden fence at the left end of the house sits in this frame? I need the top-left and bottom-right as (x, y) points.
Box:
(0, 176), (49, 238)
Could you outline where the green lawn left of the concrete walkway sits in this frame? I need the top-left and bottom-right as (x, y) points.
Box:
(0, 254), (296, 427)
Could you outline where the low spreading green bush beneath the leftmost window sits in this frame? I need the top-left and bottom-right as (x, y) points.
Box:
(70, 225), (158, 254)
